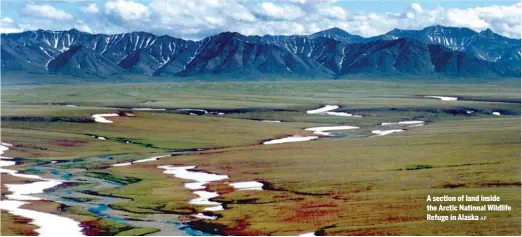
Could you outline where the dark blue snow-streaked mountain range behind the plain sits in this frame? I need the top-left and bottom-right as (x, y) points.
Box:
(1, 25), (520, 78)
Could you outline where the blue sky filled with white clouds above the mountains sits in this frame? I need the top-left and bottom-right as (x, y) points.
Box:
(0, 0), (521, 40)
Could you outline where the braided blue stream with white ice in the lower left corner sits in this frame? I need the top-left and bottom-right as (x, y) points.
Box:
(0, 146), (212, 236)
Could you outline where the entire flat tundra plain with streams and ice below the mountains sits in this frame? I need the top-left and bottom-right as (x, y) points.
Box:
(0, 79), (521, 236)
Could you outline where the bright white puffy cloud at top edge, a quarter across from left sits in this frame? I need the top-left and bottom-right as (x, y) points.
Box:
(105, 0), (150, 21)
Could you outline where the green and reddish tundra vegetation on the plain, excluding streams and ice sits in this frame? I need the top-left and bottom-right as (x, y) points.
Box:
(2, 81), (521, 235)
